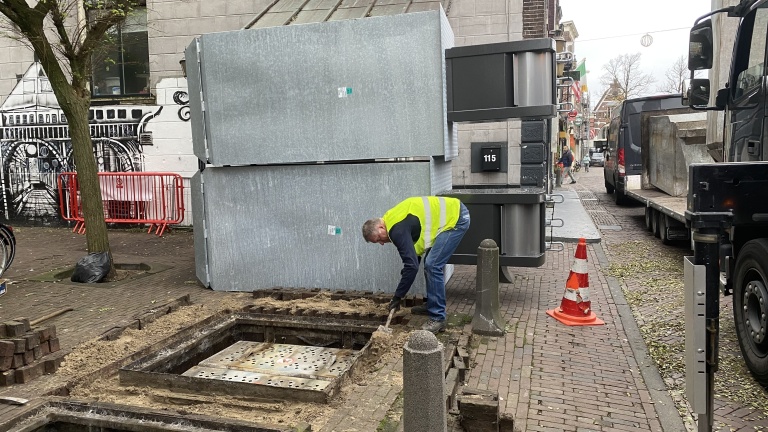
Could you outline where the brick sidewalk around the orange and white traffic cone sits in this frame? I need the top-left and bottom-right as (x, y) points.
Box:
(449, 243), (682, 431)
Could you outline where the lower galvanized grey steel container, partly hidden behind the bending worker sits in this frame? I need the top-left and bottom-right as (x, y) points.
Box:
(193, 162), (449, 294)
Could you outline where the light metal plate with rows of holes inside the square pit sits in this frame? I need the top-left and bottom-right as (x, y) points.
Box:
(182, 341), (359, 390)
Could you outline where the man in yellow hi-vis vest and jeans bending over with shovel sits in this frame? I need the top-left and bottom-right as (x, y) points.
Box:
(363, 196), (469, 334)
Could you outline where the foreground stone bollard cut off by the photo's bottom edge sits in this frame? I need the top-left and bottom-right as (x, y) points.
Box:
(403, 330), (448, 432)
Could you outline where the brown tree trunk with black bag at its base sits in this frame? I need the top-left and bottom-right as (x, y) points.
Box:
(62, 97), (114, 272)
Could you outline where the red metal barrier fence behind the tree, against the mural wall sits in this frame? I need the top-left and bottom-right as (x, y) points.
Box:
(58, 172), (184, 236)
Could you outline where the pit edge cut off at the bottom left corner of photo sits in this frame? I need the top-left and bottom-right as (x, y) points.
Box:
(0, 400), (295, 432)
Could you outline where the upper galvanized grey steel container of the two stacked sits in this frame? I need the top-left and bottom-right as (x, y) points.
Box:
(190, 10), (453, 165)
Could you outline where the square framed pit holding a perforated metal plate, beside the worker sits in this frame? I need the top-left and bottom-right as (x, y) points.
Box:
(119, 312), (379, 403)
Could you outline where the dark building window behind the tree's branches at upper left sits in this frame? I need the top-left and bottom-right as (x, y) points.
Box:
(88, 7), (149, 97)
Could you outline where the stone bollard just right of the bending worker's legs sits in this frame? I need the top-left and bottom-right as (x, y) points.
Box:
(472, 239), (505, 336)
